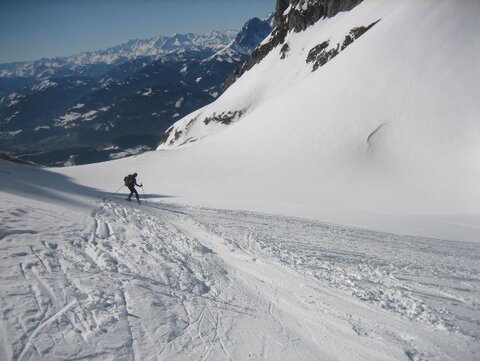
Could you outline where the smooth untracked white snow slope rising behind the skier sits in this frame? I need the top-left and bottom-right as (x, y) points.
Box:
(49, 0), (480, 241)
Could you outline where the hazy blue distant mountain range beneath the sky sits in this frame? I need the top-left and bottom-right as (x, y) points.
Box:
(0, 18), (271, 166)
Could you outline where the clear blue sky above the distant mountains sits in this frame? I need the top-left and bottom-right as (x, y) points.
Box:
(0, 0), (276, 63)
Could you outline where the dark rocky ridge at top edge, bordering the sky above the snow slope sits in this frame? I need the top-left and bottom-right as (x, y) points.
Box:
(225, 0), (363, 88)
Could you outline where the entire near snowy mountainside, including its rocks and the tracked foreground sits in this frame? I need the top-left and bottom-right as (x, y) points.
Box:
(0, 0), (480, 361)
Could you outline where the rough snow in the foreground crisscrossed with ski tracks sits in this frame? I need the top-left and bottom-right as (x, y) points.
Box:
(0, 200), (480, 361)
